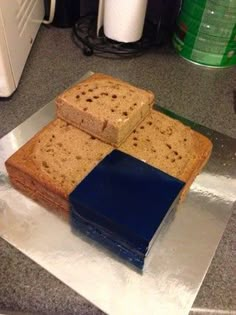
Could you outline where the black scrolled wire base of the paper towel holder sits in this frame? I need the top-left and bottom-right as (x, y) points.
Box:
(73, 15), (165, 58)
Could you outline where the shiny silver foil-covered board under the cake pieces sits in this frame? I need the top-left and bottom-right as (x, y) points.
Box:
(0, 73), (236, 315)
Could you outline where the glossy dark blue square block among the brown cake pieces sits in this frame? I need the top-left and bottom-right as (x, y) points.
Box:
(69, 150), (184, 264)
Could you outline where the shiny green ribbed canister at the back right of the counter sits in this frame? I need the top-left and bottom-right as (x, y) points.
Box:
(173, 0), (236, 67)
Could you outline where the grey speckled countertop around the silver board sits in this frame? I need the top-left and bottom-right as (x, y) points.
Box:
(0, 27), (236, 315)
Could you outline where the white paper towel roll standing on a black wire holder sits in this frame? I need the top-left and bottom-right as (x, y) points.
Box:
(104, 0), (147, 43)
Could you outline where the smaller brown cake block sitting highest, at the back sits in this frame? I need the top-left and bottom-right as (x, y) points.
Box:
(56, 73), (154, 147)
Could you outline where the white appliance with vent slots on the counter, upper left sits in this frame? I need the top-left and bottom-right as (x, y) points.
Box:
(0, 0), (55, 97)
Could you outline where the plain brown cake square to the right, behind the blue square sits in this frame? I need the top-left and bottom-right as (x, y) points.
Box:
(120, 110), (212, 199)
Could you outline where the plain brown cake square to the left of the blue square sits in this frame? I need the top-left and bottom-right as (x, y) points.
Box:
(6, 119), (112, 210)
